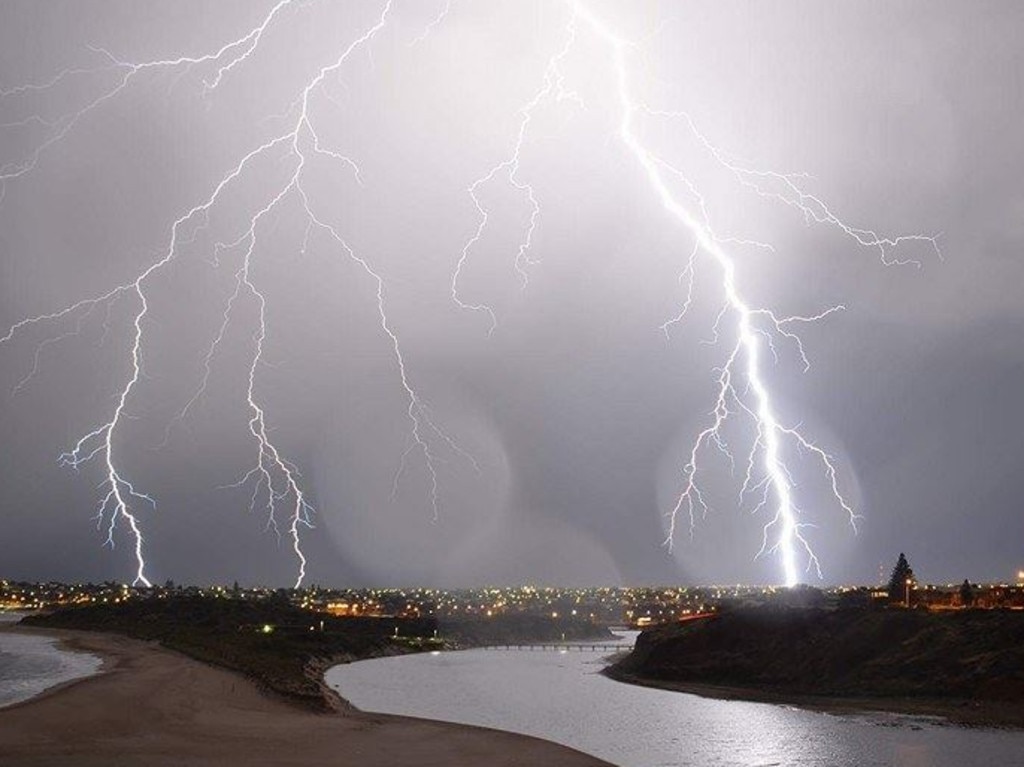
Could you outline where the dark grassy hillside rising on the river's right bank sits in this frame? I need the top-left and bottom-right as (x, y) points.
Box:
(612, 608), (1024, 702)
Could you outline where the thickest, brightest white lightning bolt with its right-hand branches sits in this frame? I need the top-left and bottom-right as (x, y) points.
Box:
(569, 0), (941, 586)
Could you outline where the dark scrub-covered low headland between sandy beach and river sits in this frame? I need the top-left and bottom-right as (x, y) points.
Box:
(24, 596), (601, 710)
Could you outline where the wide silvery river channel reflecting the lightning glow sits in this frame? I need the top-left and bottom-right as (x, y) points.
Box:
(327, 630), (1024, 767)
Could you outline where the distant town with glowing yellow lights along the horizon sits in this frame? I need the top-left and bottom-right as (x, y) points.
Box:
(0, 572), (1024, 628)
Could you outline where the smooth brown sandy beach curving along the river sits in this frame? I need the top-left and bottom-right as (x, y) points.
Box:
(0, 628), (606, 767)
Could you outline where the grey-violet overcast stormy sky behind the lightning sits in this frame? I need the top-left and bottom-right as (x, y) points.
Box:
(0, 0), (1024, 586)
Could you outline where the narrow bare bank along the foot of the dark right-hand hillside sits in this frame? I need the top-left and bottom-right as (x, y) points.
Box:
(601, 665), (1024, 730)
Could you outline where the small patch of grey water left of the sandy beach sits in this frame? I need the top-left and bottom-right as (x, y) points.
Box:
(0, 613), (102, 708)
